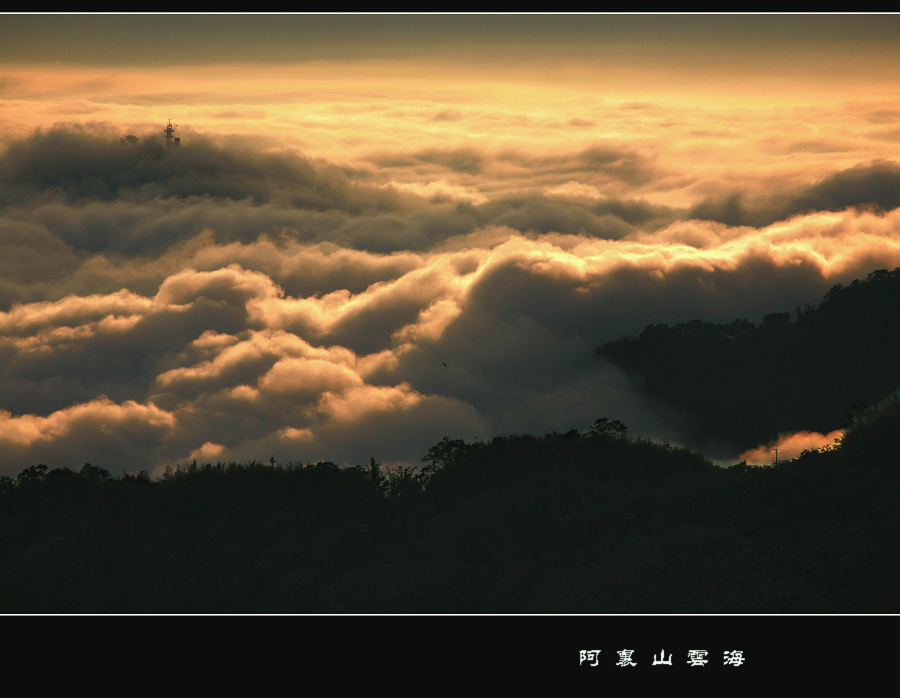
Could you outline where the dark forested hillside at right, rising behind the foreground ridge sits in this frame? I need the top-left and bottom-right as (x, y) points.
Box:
(597, 267), (900, 453)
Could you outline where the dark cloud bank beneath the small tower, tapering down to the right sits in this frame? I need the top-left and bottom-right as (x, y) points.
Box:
(0, 126), (400, 214)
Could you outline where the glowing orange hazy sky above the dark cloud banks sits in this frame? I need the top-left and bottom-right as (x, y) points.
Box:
(0, 15), (900, 205)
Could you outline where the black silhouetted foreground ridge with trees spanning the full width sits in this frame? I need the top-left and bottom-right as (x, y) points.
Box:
(0, 402), (900, 613)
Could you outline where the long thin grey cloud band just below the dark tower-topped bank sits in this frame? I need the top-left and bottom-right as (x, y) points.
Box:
(0, 188), (660, 266)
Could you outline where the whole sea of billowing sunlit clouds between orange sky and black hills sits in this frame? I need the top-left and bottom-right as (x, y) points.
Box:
(0, 114), (900, 474)
